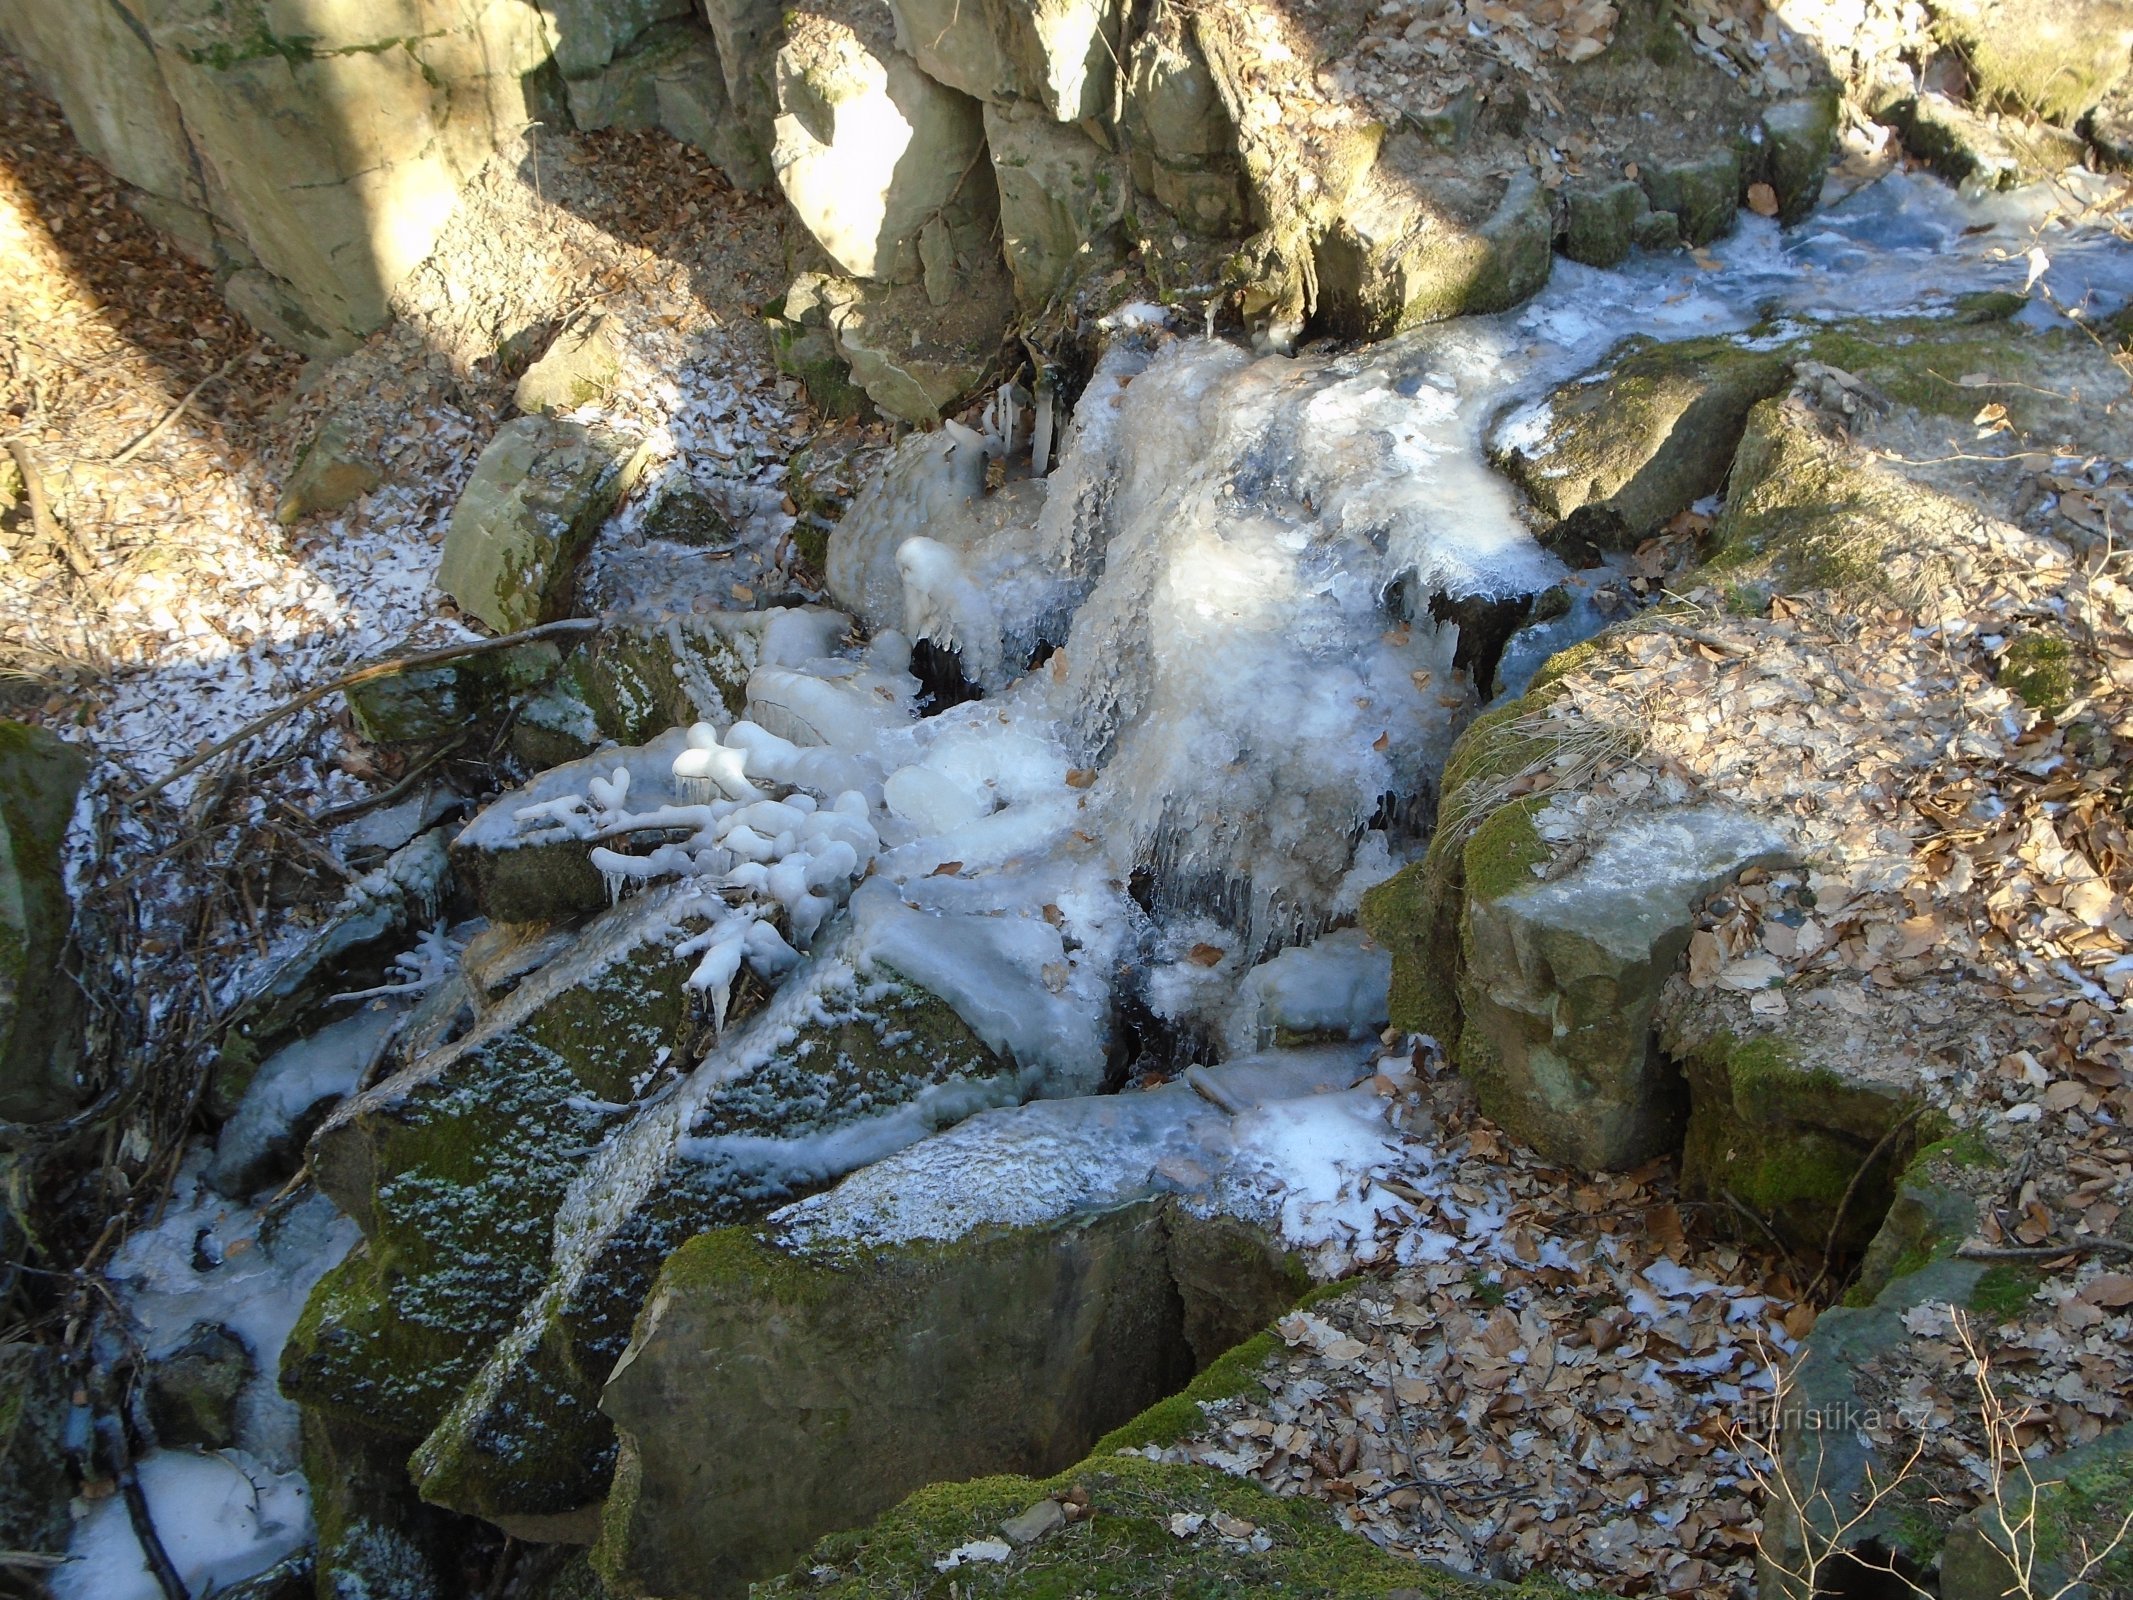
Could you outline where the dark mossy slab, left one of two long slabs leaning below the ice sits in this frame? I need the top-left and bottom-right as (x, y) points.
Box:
(282, 892), (706, 1438)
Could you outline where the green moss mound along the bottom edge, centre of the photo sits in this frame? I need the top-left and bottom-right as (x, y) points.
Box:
(755, 1455), (1531, 1600)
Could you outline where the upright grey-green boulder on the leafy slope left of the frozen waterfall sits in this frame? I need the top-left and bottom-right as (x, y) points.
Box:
(424, 416), (644, 634)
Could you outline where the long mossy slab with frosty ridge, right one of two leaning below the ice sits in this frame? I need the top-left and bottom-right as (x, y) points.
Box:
(412, 941), (1028, 1540)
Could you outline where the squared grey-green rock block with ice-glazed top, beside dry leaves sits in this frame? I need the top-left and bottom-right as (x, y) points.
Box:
(1461, 806), (1783, 1171)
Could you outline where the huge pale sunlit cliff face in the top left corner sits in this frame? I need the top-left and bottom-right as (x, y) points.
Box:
(0, 0), (548, 352)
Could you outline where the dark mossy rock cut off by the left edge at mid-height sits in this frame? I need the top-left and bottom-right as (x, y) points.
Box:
(0, 721), (90, 1122)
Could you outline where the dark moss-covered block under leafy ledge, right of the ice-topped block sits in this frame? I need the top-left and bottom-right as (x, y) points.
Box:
(1681, 1033), (1915, 1261)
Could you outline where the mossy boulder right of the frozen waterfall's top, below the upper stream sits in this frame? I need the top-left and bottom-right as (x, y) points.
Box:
(1495, 337), (1792, 550)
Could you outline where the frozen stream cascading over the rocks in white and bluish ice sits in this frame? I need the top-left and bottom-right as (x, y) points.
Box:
(55, 177), (2133, 1596)
